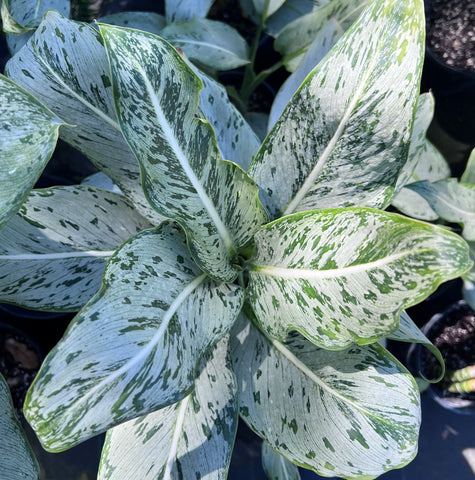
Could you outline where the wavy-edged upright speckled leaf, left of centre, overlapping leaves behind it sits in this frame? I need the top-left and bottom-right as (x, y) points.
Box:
(100, 25), (266, 281)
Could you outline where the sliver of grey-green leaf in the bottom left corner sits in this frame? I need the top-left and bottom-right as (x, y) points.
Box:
(0, 374), (40, 480)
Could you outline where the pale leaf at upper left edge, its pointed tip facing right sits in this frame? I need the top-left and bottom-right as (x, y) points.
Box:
(0, 75), (63, 228)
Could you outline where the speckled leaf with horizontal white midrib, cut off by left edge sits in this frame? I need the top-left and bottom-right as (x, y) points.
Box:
(0, 186), (152, 312)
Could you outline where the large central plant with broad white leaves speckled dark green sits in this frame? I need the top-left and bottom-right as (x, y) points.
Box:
(0, 0), (471, 479)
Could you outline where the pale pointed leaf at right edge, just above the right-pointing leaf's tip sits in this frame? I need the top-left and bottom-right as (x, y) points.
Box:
(407, 178), (475, 242)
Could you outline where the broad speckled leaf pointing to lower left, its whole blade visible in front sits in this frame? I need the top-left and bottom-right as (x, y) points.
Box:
(25, 222), (243, 451)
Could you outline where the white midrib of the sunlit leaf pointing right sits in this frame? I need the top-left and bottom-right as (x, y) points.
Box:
(251, 248), (424, 280)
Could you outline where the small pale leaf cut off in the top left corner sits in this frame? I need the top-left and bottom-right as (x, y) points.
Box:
(2, 0), (71, 55)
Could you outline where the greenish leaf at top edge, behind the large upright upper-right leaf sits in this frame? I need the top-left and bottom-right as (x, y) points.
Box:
(274, 0), (368, 72)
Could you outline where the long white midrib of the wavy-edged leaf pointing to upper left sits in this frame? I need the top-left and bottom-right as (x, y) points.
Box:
(125, 51), (235, 253)
